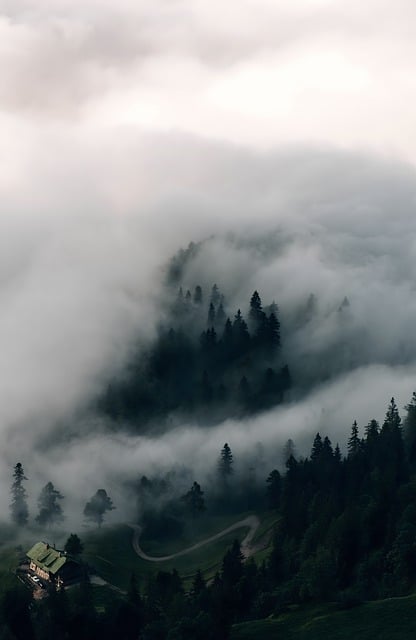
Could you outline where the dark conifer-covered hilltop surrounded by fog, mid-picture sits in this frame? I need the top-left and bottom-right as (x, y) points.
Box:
(99, 285), (291, 429)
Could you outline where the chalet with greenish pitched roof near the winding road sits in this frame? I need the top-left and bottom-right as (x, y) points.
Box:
(26, 542), (84, 588)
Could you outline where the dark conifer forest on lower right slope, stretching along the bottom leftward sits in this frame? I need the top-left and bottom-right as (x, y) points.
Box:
(3, 393), (416, 640)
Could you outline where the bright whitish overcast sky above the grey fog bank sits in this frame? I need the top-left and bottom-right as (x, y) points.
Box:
(0, 0), (416, 157)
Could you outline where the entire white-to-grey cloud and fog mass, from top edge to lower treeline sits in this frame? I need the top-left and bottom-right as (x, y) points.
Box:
(0, 0), (416, 527)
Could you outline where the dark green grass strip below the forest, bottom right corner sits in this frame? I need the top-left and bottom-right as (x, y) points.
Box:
(230, 595), (416, 640)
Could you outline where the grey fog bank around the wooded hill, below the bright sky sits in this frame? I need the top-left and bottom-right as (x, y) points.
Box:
(0, 137), (416, 519)
